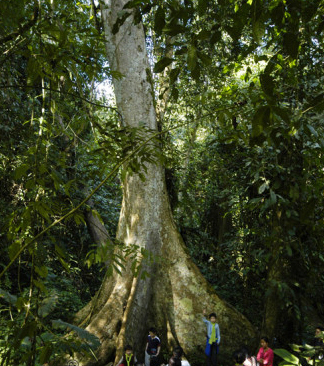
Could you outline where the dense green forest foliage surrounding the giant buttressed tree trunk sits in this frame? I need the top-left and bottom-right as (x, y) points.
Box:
(0, 0), (324, 365)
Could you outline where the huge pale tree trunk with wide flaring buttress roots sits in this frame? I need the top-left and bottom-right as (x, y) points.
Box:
(74, 0), (255, 366)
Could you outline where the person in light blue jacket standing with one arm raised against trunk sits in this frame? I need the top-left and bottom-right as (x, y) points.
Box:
(203, 310), (220, 366)
